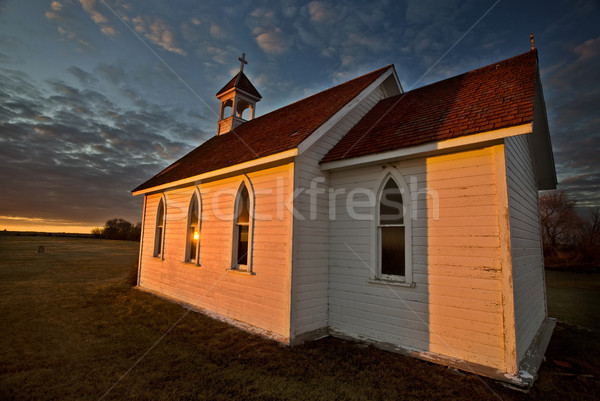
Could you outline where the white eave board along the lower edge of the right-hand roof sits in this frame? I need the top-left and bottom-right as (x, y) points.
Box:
(321, 123), (532, 171)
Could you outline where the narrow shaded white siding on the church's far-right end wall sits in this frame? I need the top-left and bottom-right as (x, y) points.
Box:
(505, 135), (547, 360)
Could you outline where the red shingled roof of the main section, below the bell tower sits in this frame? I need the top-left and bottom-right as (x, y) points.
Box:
(133, 66), (391, 192)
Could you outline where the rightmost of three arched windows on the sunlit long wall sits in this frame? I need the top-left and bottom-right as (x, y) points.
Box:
(232, 183), (252, 271)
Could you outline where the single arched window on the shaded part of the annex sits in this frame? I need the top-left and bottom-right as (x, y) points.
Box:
(376, 170), (412, 283)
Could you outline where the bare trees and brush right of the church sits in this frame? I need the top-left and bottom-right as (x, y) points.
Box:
(540, 191), (600, 267)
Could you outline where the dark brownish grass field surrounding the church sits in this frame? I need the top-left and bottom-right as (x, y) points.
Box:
(0, 236), (600, 400)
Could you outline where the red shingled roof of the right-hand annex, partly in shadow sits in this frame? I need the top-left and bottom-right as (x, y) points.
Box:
(321, 50), (537, 162)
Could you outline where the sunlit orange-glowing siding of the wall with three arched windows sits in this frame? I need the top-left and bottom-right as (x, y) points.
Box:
(140, 163), (293, 342)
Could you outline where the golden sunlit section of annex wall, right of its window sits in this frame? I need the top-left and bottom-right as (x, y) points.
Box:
(427, 145), (505, 369)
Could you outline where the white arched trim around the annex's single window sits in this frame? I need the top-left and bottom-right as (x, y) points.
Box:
(369, 167), (415, 287)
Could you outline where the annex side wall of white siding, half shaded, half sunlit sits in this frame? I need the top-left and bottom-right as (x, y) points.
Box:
(329, 145), (505, 369)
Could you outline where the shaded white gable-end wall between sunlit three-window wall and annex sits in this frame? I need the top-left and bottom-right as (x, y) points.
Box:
(292, 88), (384, 336)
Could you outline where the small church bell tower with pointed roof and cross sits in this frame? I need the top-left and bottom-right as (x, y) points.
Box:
(217, 53), (262, 135)
